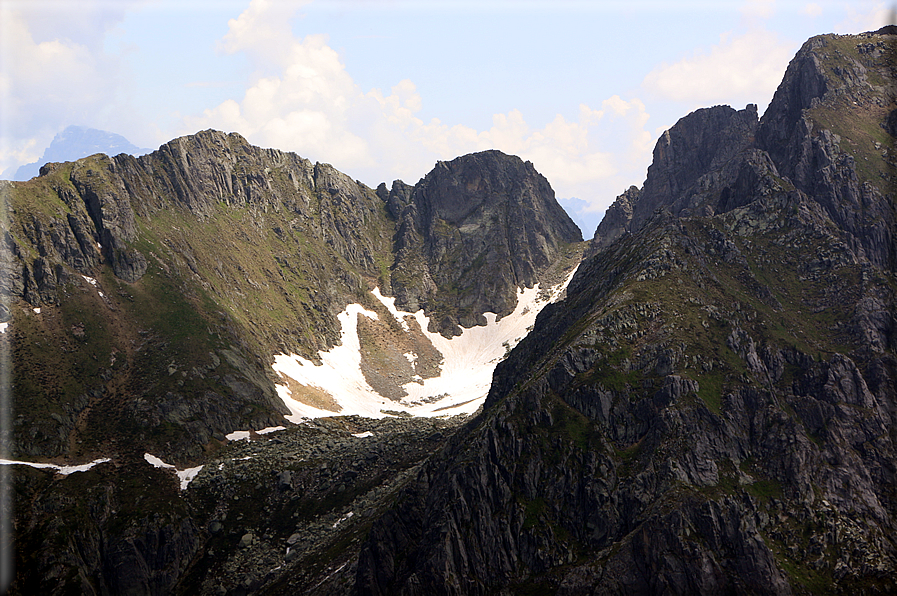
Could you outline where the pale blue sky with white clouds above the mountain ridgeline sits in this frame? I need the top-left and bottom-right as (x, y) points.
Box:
(0, 0), (891, 237)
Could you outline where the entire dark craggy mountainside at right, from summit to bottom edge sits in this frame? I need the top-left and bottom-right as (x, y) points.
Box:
(356, 32), (897, 594)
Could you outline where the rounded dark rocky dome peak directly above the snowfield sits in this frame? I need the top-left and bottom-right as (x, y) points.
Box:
(387, 150), (582, 334)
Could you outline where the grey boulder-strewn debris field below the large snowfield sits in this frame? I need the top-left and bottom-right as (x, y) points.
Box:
(181, 416), (469, 594)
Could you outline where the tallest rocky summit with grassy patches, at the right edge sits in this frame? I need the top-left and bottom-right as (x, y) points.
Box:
(757, 27), (897, 267)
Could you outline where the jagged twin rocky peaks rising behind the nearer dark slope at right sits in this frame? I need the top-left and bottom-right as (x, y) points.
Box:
(590, 29), (897, 266)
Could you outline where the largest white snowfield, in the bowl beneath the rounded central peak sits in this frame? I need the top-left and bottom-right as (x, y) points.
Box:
(273, 273), (573, 423)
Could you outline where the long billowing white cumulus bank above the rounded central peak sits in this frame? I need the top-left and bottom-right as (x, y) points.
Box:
(189, 0), (652, 217)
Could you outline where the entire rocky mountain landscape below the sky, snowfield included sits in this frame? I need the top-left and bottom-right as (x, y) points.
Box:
(0, 28), (897, 596)
